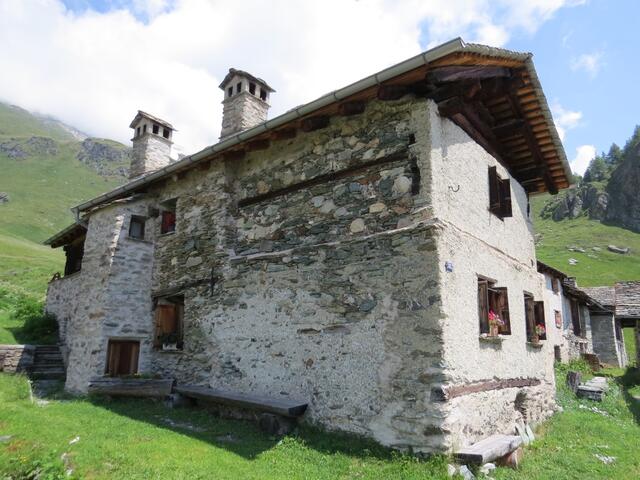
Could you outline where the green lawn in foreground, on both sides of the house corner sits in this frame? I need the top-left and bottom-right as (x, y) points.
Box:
(0, 364), (640, 480)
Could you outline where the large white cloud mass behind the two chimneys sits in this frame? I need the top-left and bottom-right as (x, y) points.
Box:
(0, 0), (576, 153)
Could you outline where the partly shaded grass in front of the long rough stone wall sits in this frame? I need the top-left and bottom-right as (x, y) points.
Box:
(0, 374), (447, 480)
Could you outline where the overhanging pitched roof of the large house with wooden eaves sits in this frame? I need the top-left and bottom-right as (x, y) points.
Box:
(67, 38), (571, 218)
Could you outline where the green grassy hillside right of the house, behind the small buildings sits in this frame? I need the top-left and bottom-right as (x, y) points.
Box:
(531, 195), (640, 287)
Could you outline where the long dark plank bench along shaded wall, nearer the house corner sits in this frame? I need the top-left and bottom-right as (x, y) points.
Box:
(175, 385), (307, 417)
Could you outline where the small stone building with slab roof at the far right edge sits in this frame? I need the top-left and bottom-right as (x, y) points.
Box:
(583, 282), (640, 367)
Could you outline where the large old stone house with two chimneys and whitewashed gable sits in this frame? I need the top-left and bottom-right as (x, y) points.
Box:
(47, 39), (570, 452)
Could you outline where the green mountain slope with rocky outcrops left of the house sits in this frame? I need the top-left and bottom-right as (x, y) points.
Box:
(0, 103), (130, 295)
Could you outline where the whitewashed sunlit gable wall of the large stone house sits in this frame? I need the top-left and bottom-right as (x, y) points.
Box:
(430, 104), (555, 447)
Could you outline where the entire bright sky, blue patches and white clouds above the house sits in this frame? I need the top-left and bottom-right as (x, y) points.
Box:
(0, 0), (640, 173)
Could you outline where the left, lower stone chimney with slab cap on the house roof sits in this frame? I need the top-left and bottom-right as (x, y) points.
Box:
(129, 110), (174, 179)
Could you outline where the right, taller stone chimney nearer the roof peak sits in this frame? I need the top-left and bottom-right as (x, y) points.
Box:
(220, 68), (275, 140)
